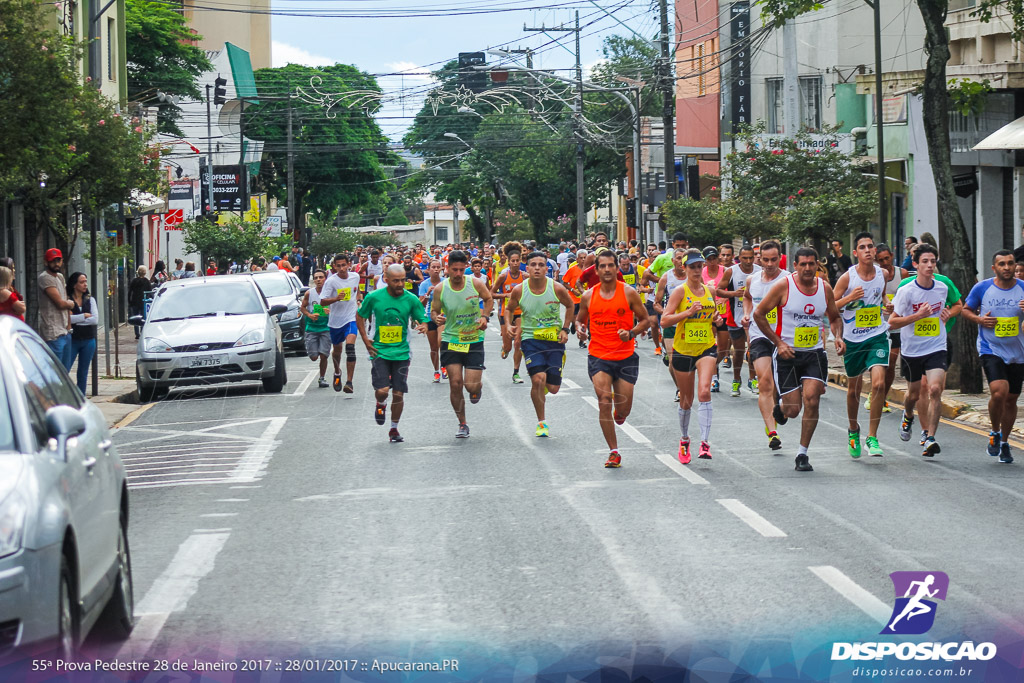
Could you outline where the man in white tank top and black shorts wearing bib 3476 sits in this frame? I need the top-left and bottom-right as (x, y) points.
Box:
(754, 245), (846, 472)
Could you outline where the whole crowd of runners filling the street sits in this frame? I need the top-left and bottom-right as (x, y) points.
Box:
(301, 232), (1024, 472)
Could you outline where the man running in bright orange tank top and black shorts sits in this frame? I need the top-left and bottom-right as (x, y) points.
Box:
(577, 250), (648, 467)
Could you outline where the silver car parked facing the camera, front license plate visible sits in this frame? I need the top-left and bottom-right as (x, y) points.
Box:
(129, 274), (288, 401)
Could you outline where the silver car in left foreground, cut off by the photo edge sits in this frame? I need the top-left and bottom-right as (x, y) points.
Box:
(0, 315), (134, 658)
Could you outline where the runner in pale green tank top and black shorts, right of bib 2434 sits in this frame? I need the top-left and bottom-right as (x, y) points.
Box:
(428, 250), (495, 438)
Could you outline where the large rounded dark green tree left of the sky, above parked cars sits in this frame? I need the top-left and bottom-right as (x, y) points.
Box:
(245, 65), (397, 241)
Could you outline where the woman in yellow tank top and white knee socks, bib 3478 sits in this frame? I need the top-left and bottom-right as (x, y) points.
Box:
(662, 249), (720, 465)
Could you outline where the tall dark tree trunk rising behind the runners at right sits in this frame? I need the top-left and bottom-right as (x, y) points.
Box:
(918, 0), (982, 393)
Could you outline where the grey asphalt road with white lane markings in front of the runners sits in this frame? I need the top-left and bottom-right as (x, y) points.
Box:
(79, 333), (1024, 675)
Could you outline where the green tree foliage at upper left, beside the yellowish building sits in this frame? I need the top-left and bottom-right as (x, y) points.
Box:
(125, 0), (213, 135)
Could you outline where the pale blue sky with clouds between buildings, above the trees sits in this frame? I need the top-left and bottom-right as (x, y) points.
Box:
(271, 0), (671, 141)
